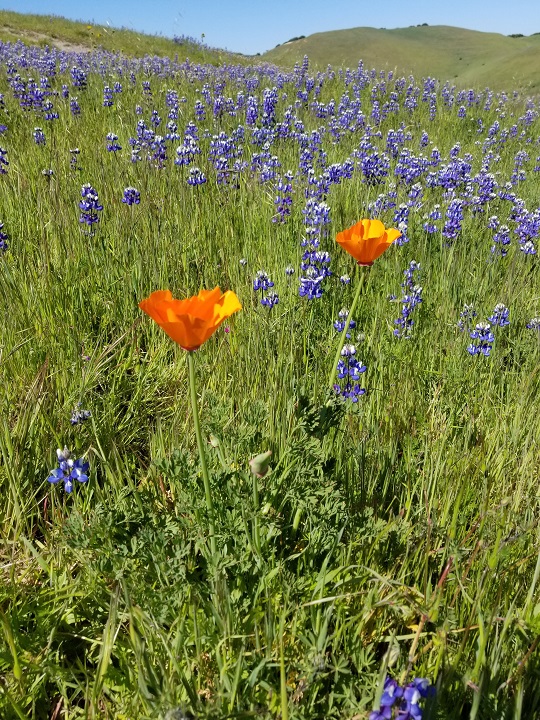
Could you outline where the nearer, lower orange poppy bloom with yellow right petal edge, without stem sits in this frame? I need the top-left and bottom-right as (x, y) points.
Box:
(139, 287), (242, 351)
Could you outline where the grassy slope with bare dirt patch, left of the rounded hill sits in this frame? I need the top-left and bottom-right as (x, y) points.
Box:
(0, 10), (245, 64)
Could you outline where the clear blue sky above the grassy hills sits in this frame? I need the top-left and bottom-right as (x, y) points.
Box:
(0, 0), (540, 54)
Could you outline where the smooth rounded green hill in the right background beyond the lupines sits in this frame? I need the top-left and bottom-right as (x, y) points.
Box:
(262, 25), (540, 91)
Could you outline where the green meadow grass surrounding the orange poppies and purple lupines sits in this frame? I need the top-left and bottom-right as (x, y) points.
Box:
(0, 40), (540, 720)
